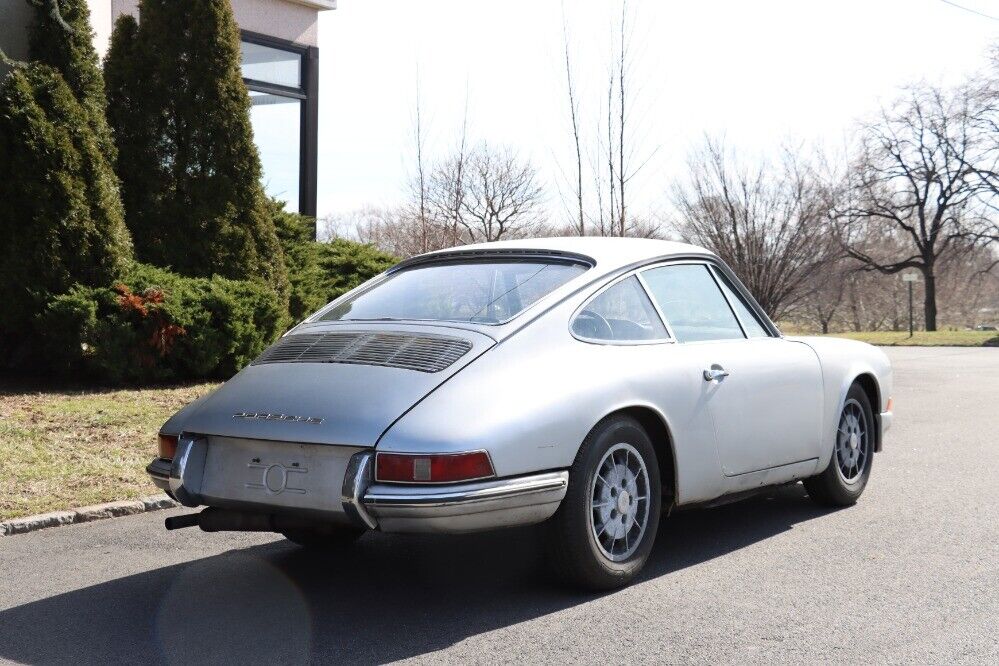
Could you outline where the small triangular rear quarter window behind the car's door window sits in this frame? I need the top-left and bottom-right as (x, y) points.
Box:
(572, 276), (669, 342)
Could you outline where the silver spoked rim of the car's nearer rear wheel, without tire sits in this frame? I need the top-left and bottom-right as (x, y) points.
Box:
(590, 443), (651, 562)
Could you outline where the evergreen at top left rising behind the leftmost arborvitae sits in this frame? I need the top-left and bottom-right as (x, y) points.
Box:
(28, 0), (115, 162)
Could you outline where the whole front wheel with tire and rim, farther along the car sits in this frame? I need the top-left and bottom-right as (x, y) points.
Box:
(805, 384), (877, 507)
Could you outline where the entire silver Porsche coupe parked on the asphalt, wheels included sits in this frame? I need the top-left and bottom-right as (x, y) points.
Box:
(148, 238), (892, 589)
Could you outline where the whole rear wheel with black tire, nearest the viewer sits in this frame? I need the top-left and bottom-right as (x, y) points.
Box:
(548, 416), (662, 590)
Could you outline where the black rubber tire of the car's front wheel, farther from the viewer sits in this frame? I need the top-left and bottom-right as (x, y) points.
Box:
(804, 384), (878, 507)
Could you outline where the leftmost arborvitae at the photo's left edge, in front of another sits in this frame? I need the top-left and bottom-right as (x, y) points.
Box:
(0, 63), (131, 348)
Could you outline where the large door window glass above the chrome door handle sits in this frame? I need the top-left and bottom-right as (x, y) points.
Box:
(642, 264), (745, 342)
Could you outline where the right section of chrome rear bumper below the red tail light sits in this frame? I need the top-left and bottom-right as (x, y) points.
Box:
(362, 471), (569, 532)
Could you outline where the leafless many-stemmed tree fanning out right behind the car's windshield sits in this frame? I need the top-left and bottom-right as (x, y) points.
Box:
(673, 139), (837, 319)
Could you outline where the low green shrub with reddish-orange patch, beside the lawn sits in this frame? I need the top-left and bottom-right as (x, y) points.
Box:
(38, 264), (286, 383)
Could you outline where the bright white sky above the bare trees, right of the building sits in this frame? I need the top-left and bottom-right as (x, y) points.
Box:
(318, 0), (999, 223)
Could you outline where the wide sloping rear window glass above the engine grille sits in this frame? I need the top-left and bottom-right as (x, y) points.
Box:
(320, 261), (586, 324)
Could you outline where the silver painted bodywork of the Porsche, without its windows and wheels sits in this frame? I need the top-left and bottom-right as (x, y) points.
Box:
(149, 238), (892, 532)
